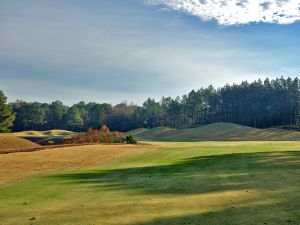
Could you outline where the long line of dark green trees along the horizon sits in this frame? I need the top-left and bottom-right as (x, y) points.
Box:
(0, 77), (300, 131)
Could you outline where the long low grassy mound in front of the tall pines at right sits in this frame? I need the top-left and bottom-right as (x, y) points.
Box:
(128, 123), (300, 141)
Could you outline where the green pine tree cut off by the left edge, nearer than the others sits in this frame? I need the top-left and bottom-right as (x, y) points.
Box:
(0, 91), (15, 133)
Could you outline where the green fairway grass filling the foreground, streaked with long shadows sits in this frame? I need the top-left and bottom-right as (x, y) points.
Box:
(0, 142), (300, 225)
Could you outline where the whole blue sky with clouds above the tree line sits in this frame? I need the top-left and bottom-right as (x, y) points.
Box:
(0, 0), (300, 105)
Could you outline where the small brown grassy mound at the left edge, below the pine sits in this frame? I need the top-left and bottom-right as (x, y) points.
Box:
(0, 135), (39, 152)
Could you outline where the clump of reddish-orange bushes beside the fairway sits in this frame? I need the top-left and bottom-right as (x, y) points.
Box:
(67, 125), (137, 144)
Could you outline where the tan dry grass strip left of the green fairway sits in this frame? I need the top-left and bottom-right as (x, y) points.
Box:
(0, 145), (154, 184)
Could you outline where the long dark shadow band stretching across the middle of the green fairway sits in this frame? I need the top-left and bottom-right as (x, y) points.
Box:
(52, 151), (300, 194)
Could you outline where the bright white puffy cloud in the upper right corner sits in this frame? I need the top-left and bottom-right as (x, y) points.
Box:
(146, 0), (300, 25)
